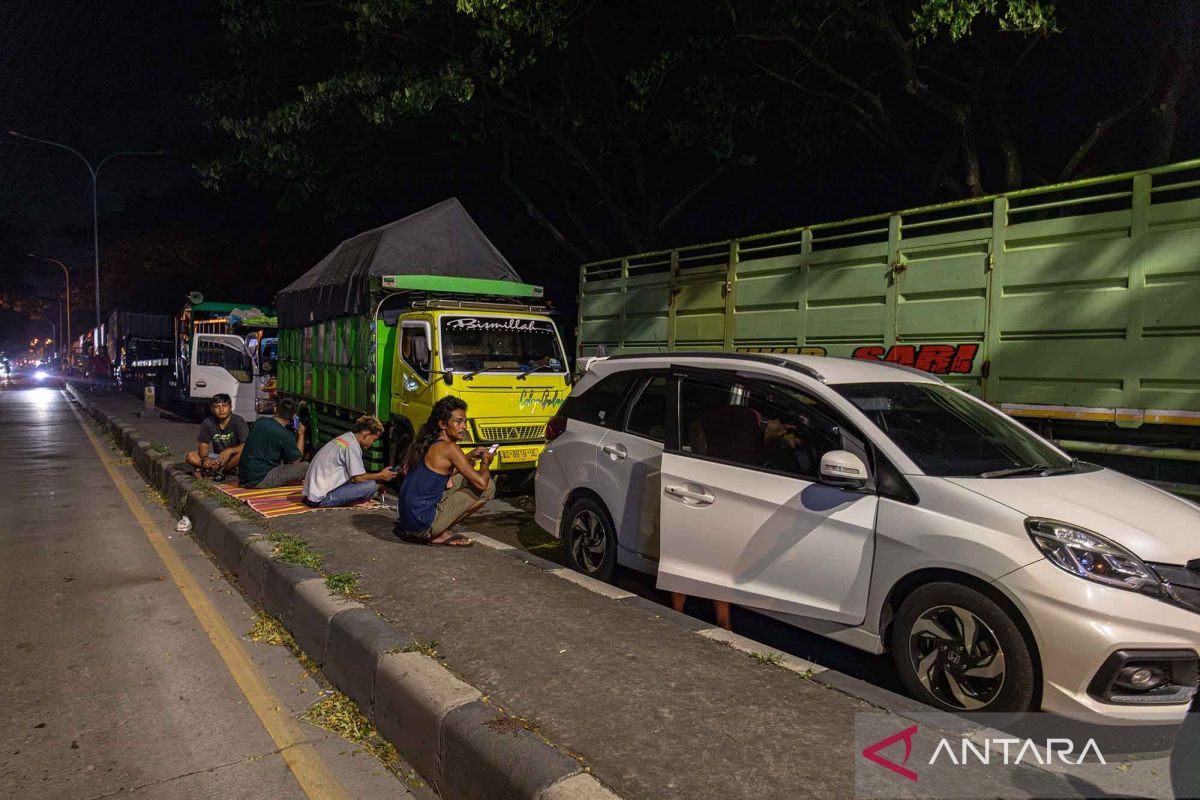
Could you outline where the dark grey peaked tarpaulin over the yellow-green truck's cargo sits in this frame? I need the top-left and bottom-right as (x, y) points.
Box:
(276, 198), (521, 327)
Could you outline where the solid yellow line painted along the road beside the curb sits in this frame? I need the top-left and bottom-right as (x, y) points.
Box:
(71, 407), (349, 800)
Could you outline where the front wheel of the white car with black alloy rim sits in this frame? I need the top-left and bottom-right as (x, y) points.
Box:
(892, 583), (1036, 711)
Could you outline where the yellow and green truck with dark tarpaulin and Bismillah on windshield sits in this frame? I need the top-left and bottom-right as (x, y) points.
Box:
(276, 199), (571, 482)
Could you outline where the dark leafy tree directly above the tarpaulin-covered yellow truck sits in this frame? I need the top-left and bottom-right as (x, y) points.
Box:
(195, 0), (760, 259)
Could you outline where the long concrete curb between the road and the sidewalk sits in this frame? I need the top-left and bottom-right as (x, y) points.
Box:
(66, 386), (617, 800)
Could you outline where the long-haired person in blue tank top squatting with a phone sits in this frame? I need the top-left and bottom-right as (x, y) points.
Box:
(395, 397), (496, 547)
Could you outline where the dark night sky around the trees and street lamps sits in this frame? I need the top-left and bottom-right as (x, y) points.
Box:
(0, 0), (1200, 357)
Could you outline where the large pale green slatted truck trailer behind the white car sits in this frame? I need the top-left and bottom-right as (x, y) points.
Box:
(576, 161), (1200, 494)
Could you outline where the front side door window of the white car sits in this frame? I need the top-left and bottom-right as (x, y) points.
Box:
(679, 377), (842, 480)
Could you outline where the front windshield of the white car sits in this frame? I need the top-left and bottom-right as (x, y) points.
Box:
(833, 383), (1074, 477)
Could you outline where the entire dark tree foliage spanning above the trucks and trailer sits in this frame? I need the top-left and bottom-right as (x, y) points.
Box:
(200, 0), (1196, 259)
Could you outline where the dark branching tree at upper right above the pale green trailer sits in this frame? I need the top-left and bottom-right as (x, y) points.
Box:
(737, 0), (1196, 198)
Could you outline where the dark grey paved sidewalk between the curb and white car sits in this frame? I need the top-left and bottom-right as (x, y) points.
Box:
(72, 395), (1171, 800)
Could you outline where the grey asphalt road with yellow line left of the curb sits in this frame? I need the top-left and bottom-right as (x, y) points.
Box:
(0, 383), (433, 800)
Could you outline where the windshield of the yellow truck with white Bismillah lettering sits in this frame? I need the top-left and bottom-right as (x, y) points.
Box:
(442, 315), (566, 373)
